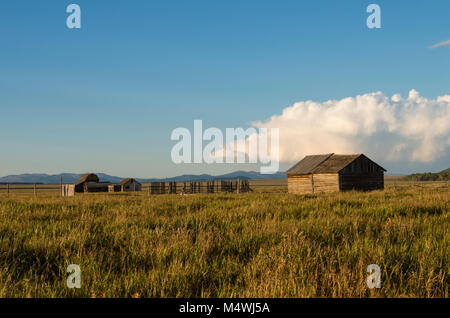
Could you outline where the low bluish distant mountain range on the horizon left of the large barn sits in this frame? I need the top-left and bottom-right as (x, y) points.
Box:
(0, 171), (286, 184)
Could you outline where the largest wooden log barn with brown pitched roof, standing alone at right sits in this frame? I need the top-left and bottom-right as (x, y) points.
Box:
(286, 153), (386, 194)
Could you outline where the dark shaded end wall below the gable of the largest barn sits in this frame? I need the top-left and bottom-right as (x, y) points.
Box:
(339, 172), (384, 191)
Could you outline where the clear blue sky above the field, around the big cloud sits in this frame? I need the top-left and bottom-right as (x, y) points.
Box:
(0, 0), (450, 177)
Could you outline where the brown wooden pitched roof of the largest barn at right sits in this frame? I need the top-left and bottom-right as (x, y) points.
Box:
(286, 153), (386, 175)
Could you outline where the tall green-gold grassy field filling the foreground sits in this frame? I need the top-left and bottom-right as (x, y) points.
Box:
(0, 182), (450, 297)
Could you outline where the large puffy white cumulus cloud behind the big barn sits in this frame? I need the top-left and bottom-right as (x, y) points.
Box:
(253, 89), (450, 162)
